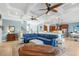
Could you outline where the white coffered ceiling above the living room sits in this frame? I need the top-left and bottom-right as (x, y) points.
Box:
(0, 3), (79, 21)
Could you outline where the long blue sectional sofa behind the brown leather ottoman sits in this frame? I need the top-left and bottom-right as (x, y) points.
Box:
(23, 34), (58, 47)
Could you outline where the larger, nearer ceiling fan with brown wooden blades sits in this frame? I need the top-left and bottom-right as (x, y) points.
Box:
(40, 3), (63, 14)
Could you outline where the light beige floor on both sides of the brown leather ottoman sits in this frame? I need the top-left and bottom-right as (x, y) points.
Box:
(0, 38), (79, 56)
